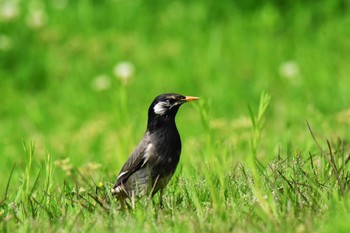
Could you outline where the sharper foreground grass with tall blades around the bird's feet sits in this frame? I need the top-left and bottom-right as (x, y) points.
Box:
(0, 95), (350, 232)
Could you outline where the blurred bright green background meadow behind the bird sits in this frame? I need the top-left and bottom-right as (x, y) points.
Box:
(0, 0), (350, 187)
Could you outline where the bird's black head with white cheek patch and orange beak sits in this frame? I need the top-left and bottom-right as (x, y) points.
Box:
(148, 93), (199, 127)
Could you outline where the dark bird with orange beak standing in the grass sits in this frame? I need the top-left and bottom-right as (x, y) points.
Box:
(112, 93), (199, 208)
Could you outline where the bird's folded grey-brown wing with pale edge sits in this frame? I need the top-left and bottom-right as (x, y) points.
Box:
(113, 133), (154, 188)
